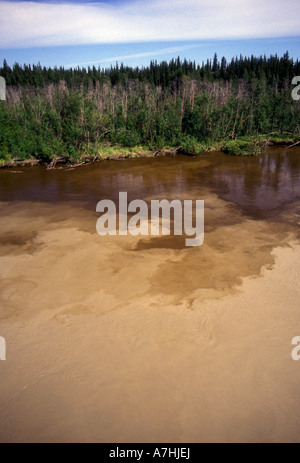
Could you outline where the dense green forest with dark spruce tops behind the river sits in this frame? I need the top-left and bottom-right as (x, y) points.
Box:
(0, 53), (300, 163)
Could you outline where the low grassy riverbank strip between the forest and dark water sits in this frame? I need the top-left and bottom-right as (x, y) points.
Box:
(0, 134), (300, 169)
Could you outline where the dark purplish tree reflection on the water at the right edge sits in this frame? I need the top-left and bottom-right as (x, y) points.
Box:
(197, 148), (300, 217)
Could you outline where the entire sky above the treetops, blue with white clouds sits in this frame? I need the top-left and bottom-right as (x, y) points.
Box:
(0, 0), (300, 67)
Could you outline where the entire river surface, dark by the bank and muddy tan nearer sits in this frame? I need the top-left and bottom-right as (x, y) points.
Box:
(0, 147), (300, 442)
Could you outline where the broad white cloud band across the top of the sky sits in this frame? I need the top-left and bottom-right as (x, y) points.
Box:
(0, 0), (300, 48)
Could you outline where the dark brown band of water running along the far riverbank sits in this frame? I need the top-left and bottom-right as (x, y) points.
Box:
(0, 147), (300, 219)
